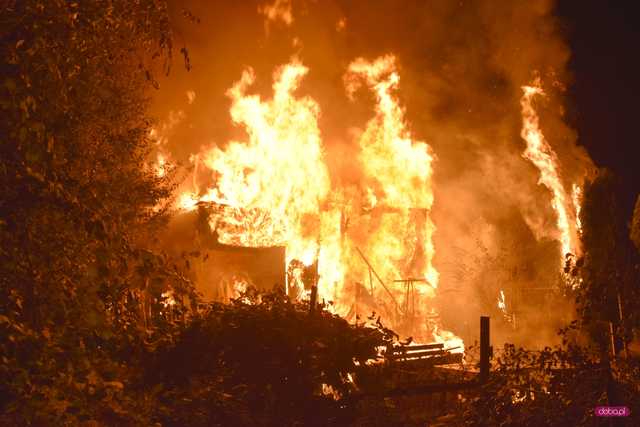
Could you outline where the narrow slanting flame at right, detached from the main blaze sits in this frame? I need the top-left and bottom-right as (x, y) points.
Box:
(520, 79), (577, 259)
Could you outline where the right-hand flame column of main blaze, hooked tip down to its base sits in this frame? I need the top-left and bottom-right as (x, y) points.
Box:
(345, 55), (456, 348)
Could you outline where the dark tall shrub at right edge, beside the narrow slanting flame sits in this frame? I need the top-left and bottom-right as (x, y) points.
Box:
(571, 170), (640, 351)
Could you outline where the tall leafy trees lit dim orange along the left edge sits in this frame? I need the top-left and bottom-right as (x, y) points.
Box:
(0, 0), (198, 425)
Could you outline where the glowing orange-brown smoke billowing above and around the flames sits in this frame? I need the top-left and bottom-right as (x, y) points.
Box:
(153, 0), (591, 344)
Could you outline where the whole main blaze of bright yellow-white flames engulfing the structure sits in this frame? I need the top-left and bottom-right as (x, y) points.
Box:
(172, 55), (463, 351)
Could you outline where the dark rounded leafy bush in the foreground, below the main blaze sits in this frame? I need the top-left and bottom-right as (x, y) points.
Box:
(148, 289), (385, 426)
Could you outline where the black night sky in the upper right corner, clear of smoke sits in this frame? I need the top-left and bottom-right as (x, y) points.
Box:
(557, 0), (640, 207)
